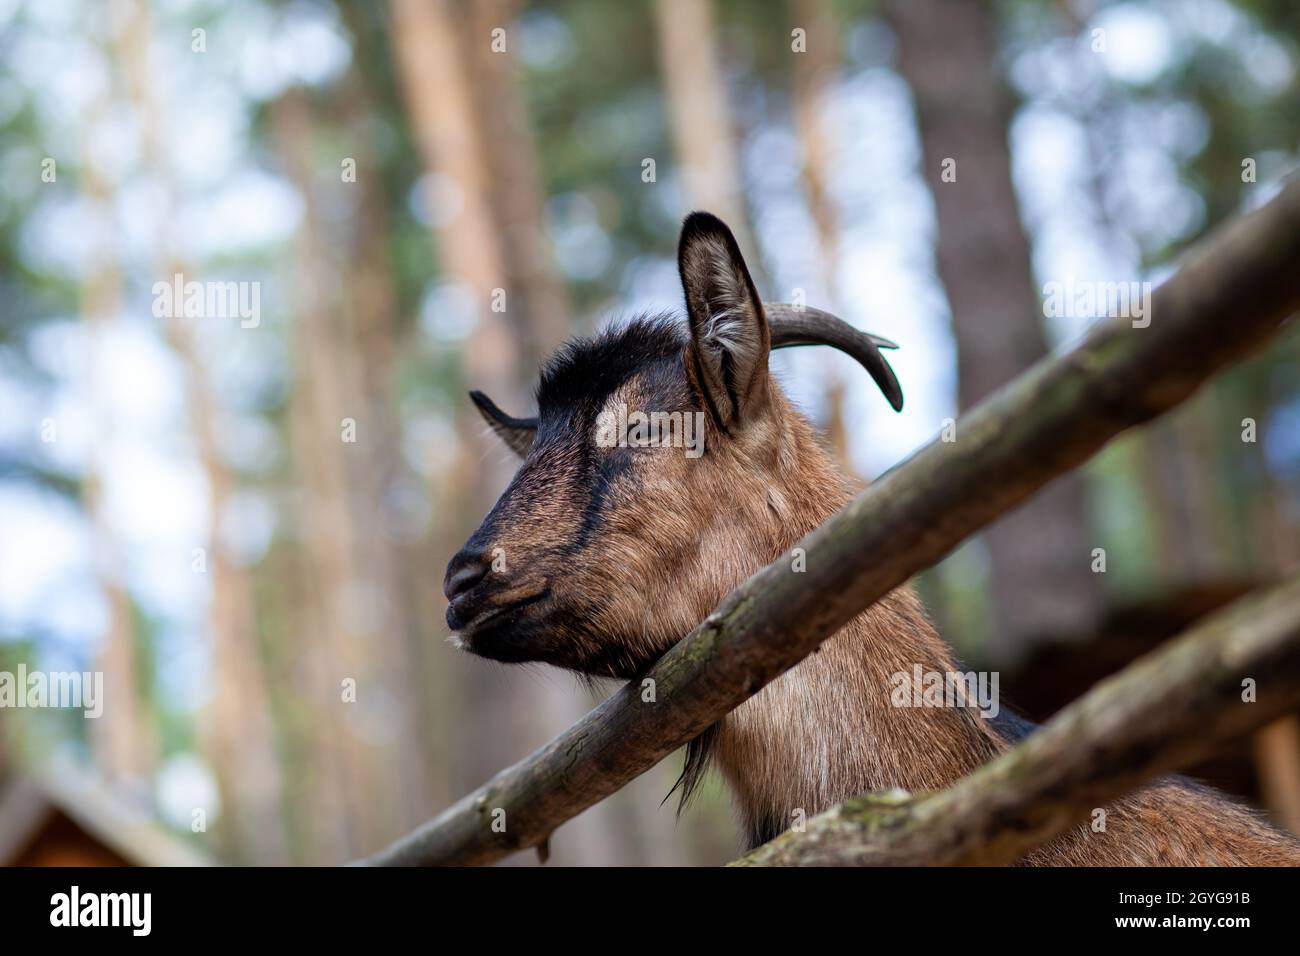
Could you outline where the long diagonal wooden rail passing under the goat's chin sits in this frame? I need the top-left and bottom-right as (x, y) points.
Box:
(368, 183), (1300, 865)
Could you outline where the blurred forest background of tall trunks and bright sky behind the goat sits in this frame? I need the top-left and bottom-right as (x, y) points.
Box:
(0, 0), (1300, 864)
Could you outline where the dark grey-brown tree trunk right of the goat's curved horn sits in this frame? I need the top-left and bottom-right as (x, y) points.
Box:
(892, 0), (1101, 661)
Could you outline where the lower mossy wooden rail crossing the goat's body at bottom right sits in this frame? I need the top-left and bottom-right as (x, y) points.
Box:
(733, 578), (1300, 866)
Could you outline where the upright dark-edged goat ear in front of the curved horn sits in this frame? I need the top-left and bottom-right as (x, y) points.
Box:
(677, 212), (771, 429)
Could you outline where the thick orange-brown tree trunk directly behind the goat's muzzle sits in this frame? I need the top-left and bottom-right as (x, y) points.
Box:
(393, 0), (631, 864)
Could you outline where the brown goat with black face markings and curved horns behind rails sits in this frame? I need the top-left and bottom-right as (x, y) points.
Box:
(443, 212), (1300, 865)
